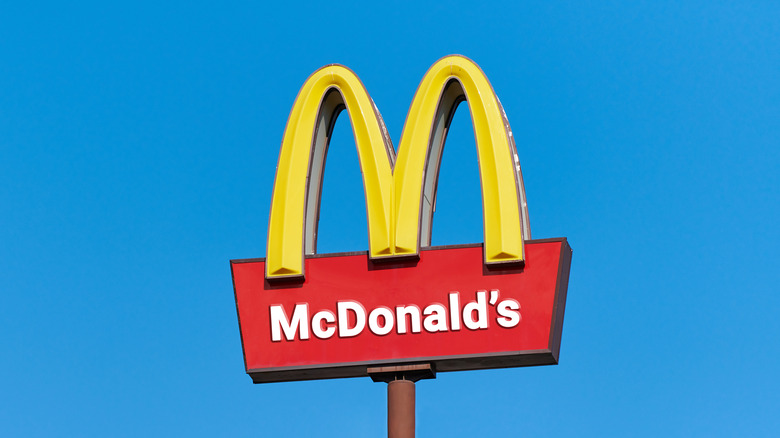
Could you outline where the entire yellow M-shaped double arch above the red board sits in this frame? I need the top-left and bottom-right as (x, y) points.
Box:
(266, 55), (530, 278)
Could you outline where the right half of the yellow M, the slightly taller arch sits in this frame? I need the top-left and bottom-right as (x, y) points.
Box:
(393, 55), (531, 264)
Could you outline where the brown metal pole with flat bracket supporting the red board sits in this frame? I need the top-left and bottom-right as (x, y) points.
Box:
(367, 363), (436, 438)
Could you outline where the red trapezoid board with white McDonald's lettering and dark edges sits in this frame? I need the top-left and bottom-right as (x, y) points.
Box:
(231, 238), (571, 383)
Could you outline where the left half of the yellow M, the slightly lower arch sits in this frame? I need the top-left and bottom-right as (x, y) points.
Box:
(266, 65), (395, 278)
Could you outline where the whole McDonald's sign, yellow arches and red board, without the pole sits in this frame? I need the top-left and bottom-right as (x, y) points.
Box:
(231, 56), (571, 383)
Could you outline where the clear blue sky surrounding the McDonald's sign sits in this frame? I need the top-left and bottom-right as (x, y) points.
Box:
(0, 1), (780, 437)
